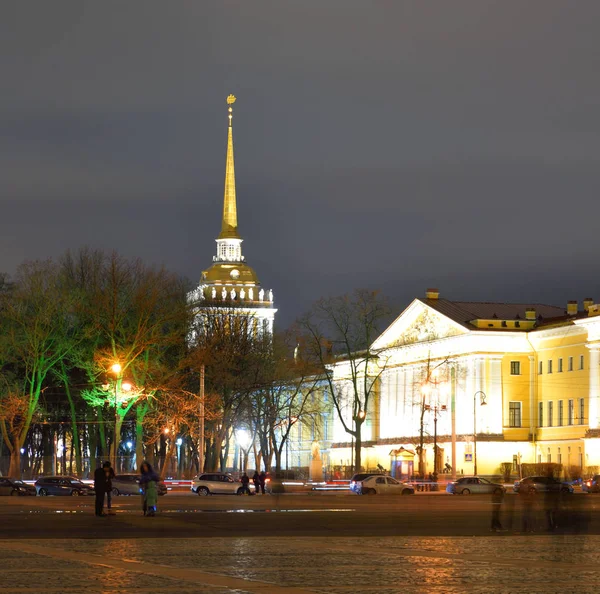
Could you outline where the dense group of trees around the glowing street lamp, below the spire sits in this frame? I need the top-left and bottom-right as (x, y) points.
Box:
(0, 248), (319, 477)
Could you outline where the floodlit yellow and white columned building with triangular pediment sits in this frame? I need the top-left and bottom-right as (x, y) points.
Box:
(330, 289), (600, 477)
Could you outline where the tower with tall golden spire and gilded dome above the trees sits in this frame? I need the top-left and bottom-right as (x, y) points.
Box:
(188, 95), (277, 335)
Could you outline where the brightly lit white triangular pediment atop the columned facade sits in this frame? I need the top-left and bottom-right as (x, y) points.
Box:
(373, 299), (469, 349)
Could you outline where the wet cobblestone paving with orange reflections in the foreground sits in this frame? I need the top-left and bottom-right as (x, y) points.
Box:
(0, 535), (600, 594)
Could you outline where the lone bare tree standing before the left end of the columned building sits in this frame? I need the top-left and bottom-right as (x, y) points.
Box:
(297, 289), (390, 471)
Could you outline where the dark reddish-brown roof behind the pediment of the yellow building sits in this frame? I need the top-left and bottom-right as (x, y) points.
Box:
(419, 299), (565, 328)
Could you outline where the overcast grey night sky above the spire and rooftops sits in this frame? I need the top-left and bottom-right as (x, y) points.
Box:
(0, 0), (600, 328)
